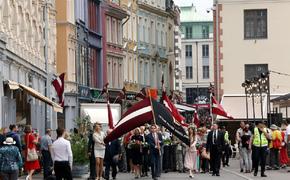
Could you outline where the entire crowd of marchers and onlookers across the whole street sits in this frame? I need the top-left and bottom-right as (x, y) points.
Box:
(0, 121), (290, 180)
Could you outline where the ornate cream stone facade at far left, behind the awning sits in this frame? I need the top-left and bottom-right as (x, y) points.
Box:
(0, 0), (56, 133)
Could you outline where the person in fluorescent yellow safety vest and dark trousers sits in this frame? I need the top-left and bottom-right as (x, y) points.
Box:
(252, 121), (270, 177)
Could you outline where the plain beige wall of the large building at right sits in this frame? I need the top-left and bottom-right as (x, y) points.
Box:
(218, 0), (290, 94)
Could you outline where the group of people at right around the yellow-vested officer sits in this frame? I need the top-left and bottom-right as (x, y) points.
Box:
(236, 121), (290, 177)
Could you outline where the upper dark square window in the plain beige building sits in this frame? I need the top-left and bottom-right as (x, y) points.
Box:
(244, 9), (267, 39)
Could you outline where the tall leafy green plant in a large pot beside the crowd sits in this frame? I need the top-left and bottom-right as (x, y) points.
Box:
(70, 116), (90, 177)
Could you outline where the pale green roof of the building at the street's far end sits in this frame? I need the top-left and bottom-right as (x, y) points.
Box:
(180, 5), (213, 22)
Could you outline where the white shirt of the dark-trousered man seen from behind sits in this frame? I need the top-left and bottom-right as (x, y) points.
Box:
(52, 137), (73, 166)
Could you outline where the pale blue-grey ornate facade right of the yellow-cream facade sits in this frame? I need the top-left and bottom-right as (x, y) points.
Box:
(134, 0), (169, 89)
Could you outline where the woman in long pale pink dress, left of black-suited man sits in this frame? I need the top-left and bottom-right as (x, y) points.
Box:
(184, 126), (197, 178)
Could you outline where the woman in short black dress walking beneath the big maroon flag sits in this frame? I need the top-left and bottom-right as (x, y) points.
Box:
(130, 128), (143, 179)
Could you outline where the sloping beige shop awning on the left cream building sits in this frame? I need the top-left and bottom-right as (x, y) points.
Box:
(7, 80), (63, 112)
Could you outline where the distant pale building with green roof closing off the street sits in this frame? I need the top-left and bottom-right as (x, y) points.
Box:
(180, 5), (214, 104)
